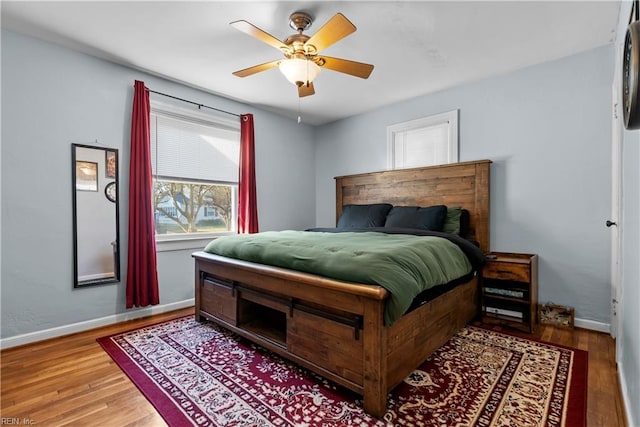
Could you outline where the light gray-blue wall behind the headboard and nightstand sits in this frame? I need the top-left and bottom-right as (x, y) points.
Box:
(316, 46), (614, 323)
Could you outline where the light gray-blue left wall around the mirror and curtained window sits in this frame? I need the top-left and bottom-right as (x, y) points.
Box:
(1, 31), (315, 338)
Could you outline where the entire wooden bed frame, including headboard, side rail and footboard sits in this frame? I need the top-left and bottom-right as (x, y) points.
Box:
(193, 160), (491, 417)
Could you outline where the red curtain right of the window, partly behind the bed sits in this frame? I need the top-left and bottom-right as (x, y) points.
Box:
(238, 114), (258, 233)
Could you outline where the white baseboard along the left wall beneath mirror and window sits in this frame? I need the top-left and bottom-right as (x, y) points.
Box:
(0, 298), (195, 350)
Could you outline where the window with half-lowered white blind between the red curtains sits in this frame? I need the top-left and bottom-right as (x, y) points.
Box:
(151, 103), (240, 247)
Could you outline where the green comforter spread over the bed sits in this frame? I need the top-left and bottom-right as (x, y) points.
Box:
(204, 231), (472, 325)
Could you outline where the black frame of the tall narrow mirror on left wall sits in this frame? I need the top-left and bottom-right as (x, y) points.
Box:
(71, 143), (120, 288)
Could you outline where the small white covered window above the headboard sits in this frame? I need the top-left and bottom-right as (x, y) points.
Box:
(387, 110), (458, 169)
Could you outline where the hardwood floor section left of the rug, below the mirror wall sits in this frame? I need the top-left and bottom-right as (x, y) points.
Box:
(0, 307), (193, 427)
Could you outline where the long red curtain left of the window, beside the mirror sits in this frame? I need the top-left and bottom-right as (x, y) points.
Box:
(126, 80), (160, 308)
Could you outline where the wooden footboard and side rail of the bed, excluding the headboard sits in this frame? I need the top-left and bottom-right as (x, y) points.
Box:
(193, 252), (475, 417)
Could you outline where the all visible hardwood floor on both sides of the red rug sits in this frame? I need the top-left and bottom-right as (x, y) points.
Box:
(0, 308), (626, 427)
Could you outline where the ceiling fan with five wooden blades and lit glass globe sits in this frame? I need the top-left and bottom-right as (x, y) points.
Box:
(230, 12), (373, 97)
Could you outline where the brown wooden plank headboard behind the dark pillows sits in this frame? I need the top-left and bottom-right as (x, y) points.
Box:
(335, 160), (491, 253)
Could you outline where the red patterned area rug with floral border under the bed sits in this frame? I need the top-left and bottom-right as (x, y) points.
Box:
(98, 316), (587, 427)
